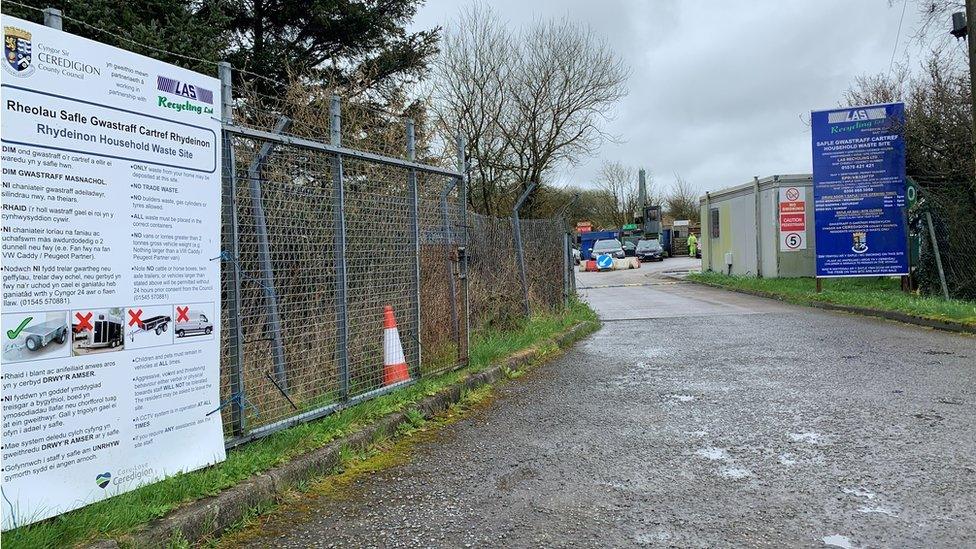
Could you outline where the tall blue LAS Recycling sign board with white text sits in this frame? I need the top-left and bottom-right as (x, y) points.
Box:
(811, 103), (909, 277)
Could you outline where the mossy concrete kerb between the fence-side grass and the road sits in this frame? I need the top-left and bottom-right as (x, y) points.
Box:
(95, 321), (599, 549)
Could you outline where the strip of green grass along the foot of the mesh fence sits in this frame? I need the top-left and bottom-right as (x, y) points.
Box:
(2, 302), (597, 549)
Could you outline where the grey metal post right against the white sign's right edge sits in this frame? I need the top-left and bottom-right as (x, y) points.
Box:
(217, 62), (247, 437)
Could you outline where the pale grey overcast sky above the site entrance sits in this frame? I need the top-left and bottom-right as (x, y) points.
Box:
(414, 0), (932, 197)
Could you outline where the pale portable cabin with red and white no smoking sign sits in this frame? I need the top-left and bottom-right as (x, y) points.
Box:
(698, 174), (816, 278)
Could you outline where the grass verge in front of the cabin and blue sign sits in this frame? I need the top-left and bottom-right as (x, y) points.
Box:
(688, 272), (976, 326)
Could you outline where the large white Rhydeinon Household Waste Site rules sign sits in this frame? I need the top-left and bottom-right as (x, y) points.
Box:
(0, 17), (224, 530)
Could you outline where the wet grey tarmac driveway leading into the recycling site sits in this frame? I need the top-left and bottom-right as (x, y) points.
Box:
(231, 259), (976, 547)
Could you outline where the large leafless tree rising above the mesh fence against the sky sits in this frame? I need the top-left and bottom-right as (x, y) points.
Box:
(432, 4), (628, 216)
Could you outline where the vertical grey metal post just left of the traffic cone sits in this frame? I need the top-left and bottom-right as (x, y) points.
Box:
(329, 95), (349, 401)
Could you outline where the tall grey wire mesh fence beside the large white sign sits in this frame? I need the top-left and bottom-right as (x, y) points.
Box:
(221, 67), (569, 444)
